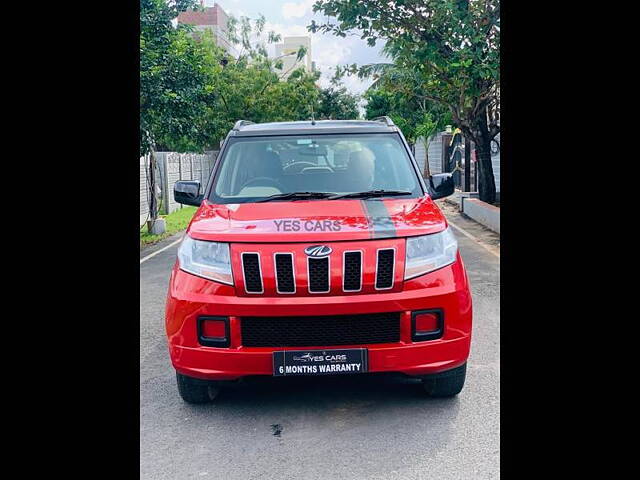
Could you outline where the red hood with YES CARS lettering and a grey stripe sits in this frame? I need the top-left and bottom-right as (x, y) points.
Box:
(188, 196), (447, 243)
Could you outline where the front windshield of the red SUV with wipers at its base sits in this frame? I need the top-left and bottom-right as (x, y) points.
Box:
(209, 134), (423, 203)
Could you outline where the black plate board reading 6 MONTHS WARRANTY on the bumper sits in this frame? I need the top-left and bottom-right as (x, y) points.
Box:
(273, 348), (368, 377)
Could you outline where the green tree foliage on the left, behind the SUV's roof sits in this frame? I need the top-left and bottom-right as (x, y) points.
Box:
(140, 0), (358, 155)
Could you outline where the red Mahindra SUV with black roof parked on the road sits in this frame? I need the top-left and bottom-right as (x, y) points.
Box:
(166, 117), (471, 403)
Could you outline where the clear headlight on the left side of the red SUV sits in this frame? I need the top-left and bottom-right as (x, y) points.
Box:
(178, 235), (233, 285)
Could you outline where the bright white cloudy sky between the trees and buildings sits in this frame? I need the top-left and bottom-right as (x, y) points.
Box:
(205, 0), (385, 94)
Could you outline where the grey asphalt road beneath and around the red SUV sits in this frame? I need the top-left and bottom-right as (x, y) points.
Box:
(140, 204), (500, 480)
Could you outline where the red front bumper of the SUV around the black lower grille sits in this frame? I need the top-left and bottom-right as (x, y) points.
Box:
(166, 254), (472, 380)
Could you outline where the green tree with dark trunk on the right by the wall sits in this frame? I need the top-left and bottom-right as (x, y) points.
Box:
(309, 0), (500, 203)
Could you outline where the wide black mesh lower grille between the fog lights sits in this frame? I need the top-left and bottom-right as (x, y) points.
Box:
(240, 312), (400, 347)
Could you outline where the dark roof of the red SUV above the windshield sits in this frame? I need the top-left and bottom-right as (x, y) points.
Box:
(229, 117), (398, 137)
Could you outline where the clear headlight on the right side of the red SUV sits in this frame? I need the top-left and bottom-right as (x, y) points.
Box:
(404, 227), (458, 280)
